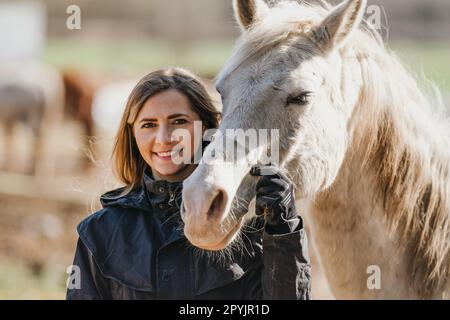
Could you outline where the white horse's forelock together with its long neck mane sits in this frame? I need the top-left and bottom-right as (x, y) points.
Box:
(224, 0), (450, 297)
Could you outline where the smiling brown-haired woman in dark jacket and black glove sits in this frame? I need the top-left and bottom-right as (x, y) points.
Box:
(67, 68), (311, 299)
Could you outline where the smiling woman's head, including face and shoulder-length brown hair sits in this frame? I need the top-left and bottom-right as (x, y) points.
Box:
(113, 68), (220, 194)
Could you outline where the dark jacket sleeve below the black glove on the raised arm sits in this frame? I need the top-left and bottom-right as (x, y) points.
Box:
(261, 218), (311, 300)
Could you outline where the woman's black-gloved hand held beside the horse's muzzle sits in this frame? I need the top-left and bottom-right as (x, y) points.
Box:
(250, 166), (303, 234)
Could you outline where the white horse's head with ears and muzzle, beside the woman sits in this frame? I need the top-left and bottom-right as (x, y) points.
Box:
(182, 0), (366, 251)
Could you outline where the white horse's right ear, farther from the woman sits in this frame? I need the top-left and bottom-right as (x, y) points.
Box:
(314, 0), (366, 49)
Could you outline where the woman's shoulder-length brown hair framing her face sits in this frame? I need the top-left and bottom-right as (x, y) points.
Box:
(112, 68), (220, 195)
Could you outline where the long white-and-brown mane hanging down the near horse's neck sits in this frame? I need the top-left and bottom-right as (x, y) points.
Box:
(326, 48), (450, 296)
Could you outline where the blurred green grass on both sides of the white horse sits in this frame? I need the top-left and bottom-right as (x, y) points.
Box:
(44, 39), (450, 92)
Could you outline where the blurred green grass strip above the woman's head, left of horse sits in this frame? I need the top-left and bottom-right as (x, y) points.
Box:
(44, 39), (236, 76)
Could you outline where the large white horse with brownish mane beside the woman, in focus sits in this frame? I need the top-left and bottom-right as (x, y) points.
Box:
(182, 0), (450, 299)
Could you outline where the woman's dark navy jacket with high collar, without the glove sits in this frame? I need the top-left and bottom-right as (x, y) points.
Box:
(67, 171), (311, 300)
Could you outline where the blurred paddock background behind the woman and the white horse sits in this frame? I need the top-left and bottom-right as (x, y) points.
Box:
(0, 0), (450, 299)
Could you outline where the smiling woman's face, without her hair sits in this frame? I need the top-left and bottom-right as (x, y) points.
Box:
(133, 89), (201, 177)
